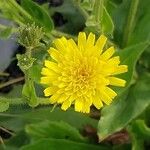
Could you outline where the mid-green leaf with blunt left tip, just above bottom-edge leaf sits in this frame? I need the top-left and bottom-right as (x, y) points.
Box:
(25, 121), (85, 142)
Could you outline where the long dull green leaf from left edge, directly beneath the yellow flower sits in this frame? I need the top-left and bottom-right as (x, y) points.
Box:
(0, 105), (98, 132)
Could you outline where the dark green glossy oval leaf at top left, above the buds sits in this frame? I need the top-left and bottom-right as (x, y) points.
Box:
(21, 0), (54, 32)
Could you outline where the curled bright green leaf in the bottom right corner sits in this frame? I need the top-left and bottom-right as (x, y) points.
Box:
(128, 120), (150, 150)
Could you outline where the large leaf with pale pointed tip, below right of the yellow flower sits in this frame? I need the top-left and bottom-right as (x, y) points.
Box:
(98, 74), (150, 140)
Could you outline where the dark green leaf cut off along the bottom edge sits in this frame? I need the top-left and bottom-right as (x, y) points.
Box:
(21, 139), (111, 150)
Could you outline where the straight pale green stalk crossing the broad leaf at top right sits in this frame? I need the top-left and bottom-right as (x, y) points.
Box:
(122, 0), (139, 47)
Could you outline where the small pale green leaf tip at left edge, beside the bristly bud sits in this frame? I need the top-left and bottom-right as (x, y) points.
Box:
(0, 27), (12, 39)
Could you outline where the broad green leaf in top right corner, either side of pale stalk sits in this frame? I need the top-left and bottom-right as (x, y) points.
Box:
(111, 0), (150, 46)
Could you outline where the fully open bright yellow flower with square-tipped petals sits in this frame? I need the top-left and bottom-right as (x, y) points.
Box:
(41, 32), (128, 113)
